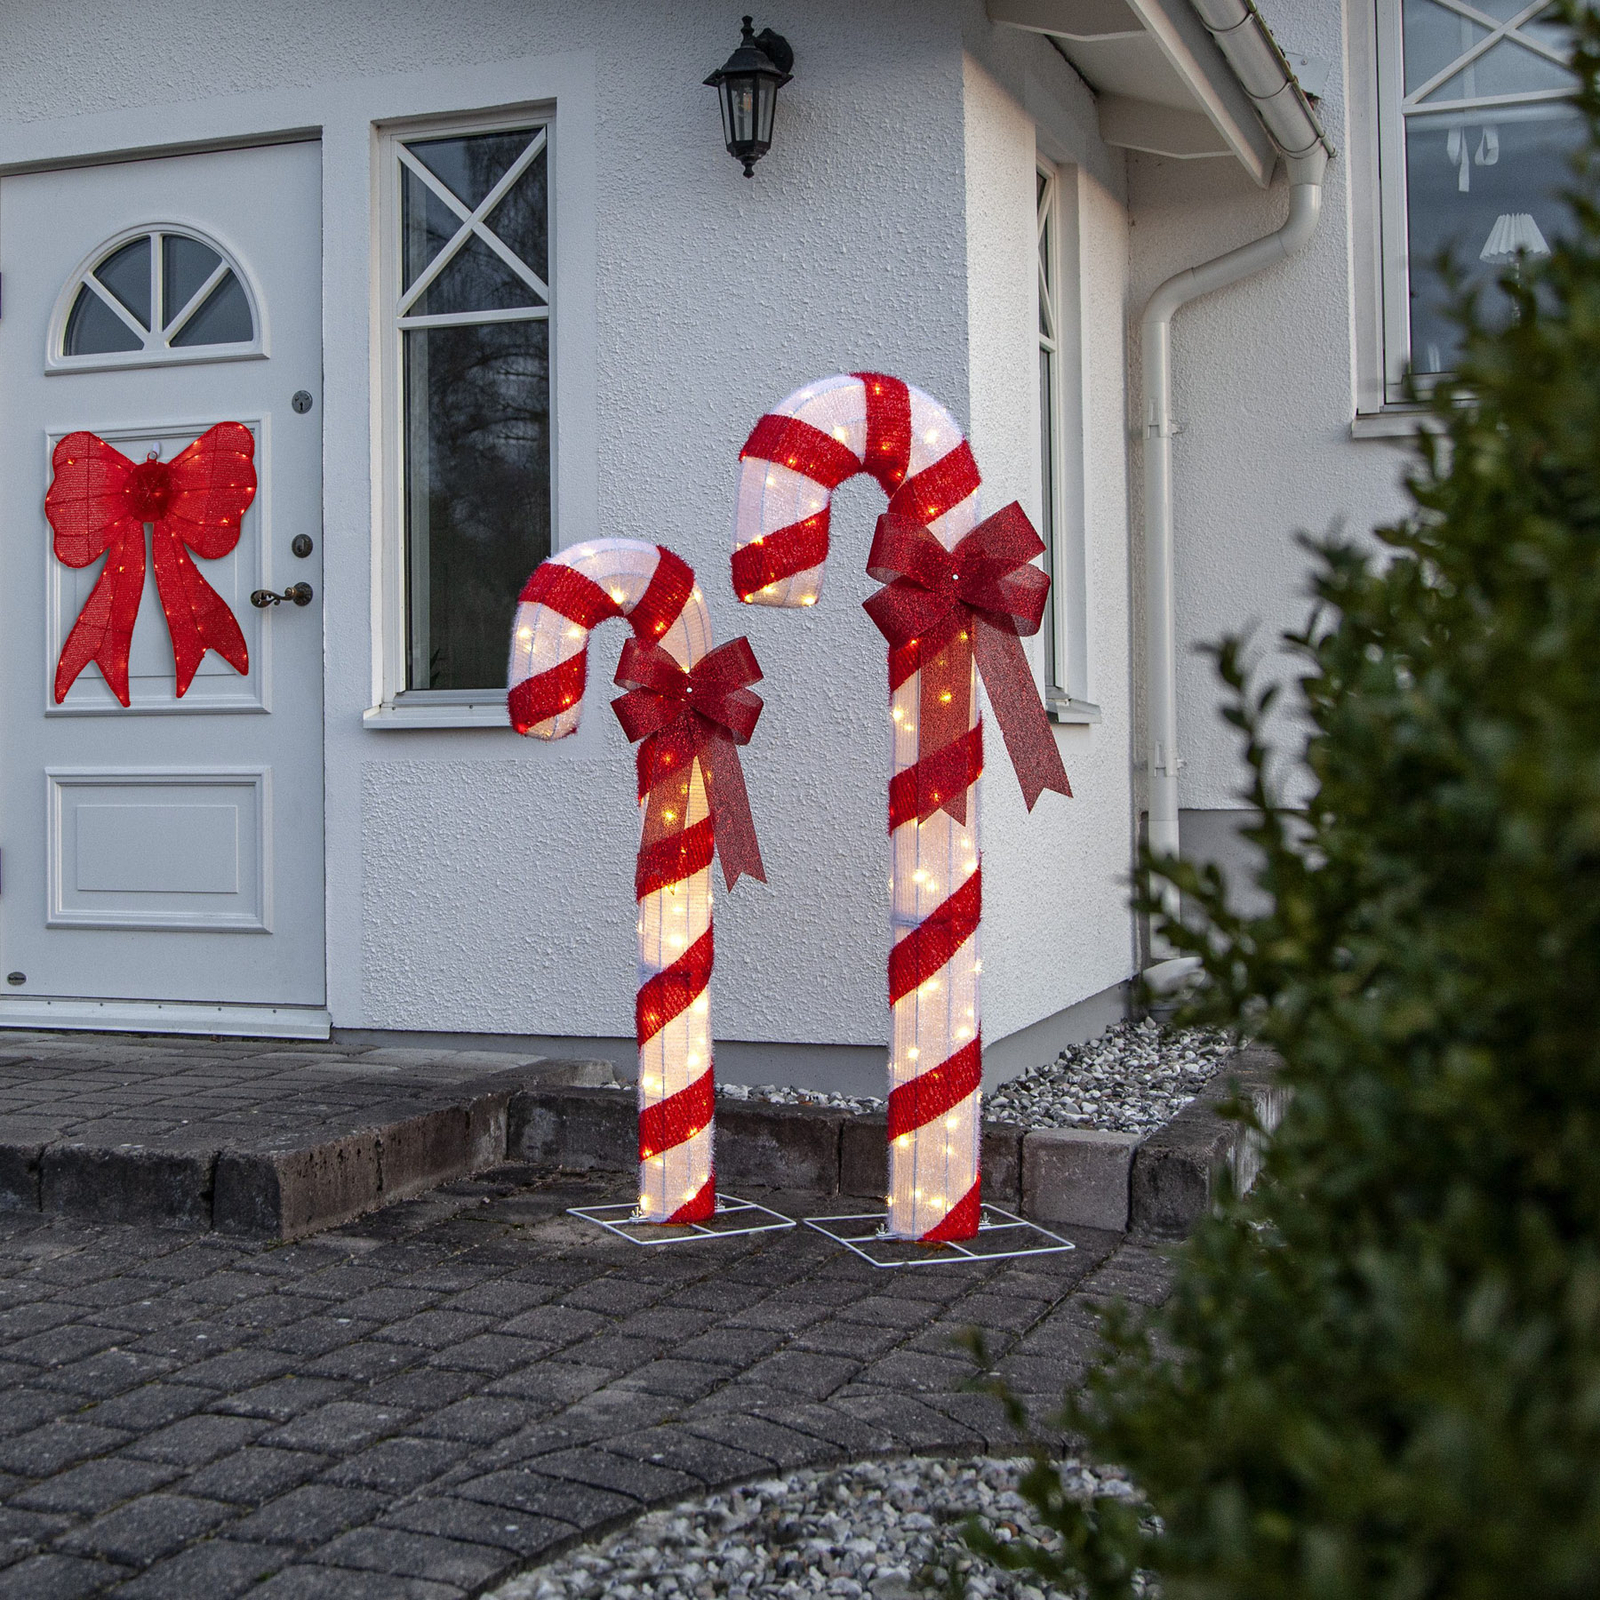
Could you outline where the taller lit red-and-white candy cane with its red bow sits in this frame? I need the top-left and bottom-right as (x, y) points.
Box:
(733, 373), (1072, 1243)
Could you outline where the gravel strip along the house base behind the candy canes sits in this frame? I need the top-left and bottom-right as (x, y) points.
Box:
(717, 1019), (1234, 1133)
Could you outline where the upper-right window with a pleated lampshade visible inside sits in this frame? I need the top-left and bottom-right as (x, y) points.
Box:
(1376, 0), (1582, 400)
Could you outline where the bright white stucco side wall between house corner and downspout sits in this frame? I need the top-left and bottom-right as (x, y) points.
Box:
(965, 27), (1133, 1040)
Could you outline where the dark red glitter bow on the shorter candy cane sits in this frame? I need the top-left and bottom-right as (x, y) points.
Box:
(611, 638), (766, 890)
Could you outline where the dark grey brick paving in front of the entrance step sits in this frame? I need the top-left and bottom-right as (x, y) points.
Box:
(0, 1170), (1165, 1600)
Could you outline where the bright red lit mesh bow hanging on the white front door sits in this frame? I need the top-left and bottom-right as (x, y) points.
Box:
(45, 422), (256, 706)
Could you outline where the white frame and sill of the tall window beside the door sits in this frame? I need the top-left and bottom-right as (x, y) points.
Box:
(365, 102), (560, 728)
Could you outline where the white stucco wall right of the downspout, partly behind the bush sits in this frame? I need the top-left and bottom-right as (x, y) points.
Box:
(1128, 0), (1405, 810)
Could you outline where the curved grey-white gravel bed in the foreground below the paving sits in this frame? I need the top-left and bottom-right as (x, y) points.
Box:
(485, 1456), (1142, 1600)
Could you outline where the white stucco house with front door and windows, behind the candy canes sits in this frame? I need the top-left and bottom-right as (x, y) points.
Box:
(0, 0), (1571, 1090)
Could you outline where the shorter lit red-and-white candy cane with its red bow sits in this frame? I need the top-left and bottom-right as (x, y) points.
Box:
(507, 539), (763, 1222)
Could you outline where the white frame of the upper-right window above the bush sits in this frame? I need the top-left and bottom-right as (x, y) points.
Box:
(1347, 0), (1566, 425)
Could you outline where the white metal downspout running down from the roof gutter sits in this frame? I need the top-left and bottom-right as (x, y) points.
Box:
(1141, 0), (1331, 987)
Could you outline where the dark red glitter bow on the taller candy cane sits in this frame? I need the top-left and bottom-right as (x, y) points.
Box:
(862, 501), (1072, 822)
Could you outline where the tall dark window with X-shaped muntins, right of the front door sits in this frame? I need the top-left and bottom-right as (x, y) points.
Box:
(384, 117), (552, 699)
